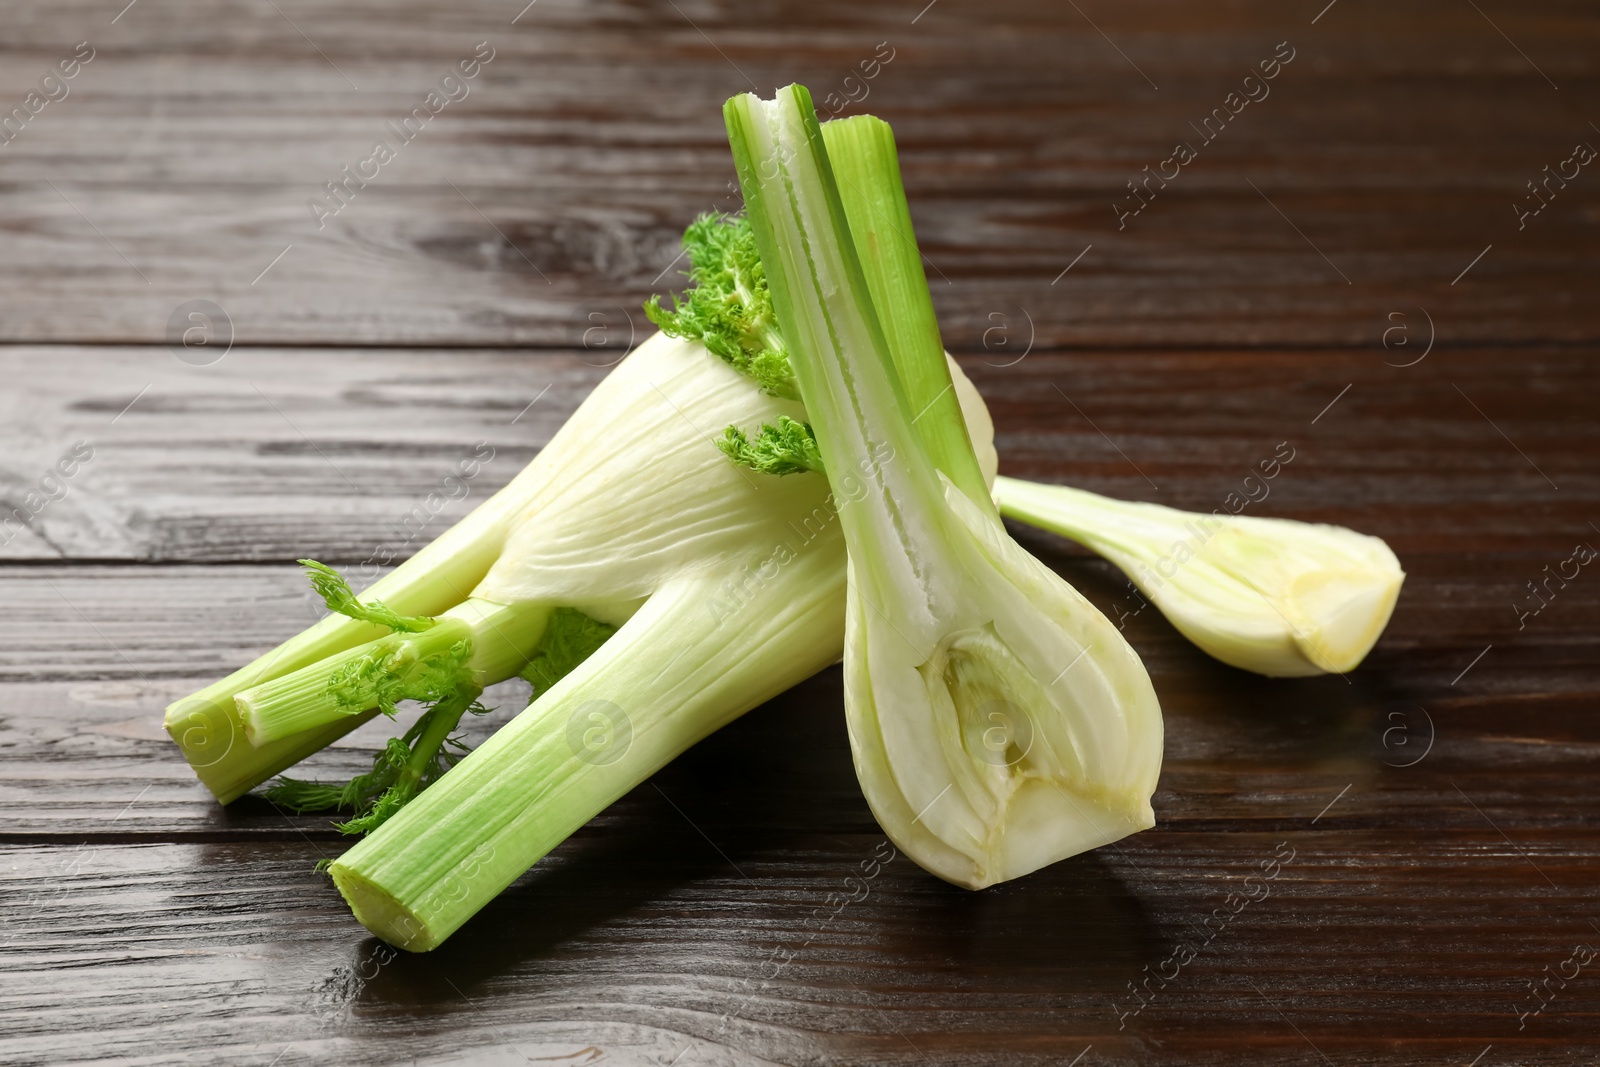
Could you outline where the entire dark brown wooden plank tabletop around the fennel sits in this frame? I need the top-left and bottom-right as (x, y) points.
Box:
(0, 0), (1600, 1067)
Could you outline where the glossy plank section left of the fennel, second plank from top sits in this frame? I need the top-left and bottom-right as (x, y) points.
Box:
(0, 347), (595, 563)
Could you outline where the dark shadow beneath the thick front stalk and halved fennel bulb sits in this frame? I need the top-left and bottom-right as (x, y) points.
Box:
(344, 669), (1160, 1011)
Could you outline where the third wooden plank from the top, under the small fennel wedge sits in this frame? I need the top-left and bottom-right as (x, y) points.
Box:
(12, 533), (1600, 840)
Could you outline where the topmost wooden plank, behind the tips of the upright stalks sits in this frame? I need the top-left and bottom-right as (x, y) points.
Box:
(0, 0), (1600, 349)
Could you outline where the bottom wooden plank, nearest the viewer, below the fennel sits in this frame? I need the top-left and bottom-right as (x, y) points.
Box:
(0, 831), (1600, 1065)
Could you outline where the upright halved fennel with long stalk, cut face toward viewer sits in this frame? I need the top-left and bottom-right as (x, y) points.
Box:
(725, 86), (1162, 888)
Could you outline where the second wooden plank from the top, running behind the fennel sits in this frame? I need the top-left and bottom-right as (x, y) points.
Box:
(0, 346), (1600, 566)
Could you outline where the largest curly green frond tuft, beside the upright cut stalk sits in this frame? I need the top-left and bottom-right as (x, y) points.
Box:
(645, 214), (798, 400)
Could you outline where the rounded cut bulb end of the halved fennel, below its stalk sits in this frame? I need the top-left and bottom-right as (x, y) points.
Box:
(845, 478), (1162, 888)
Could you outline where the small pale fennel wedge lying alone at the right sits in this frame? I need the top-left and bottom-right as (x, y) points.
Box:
(995, 478), (1405, 677)
